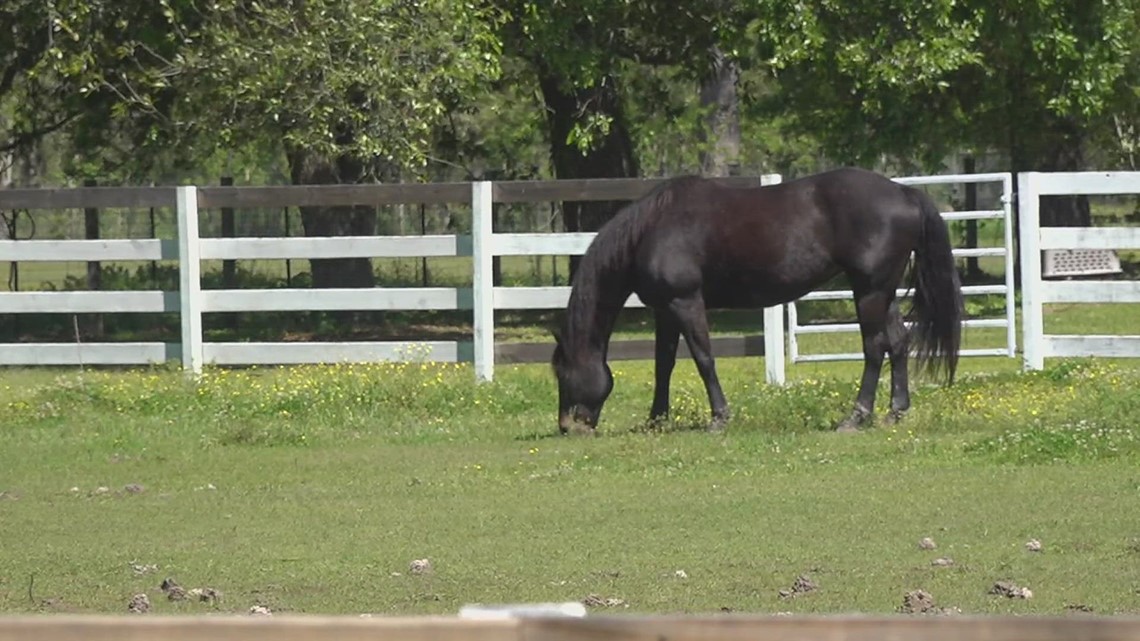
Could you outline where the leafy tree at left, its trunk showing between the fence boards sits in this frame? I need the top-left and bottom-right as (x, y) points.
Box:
(8, 0), (499, 286)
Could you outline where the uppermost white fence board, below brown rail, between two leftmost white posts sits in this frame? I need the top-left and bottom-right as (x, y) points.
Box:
(201, 235), (471, 260)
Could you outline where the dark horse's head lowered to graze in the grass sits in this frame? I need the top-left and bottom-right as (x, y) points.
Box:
(552, 335), (613, 433)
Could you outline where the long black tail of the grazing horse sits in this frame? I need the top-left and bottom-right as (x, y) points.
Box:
(909, 189), (966, 383)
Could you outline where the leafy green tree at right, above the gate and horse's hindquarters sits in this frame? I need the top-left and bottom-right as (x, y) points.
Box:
(754, 0), (1140, 224)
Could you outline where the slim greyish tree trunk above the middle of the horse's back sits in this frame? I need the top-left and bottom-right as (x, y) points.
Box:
(701, 47), (740, 176)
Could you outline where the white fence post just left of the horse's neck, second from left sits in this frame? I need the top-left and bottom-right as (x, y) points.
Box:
(471, 180), (495, 381)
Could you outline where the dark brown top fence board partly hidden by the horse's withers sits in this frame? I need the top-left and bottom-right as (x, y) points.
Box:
(492, 175), (772, 203)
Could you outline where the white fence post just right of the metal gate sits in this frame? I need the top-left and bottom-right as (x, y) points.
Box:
(1017, 171), (1045, 370)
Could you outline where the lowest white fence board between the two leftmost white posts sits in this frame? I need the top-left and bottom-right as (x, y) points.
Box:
(202, 341), (473, 365)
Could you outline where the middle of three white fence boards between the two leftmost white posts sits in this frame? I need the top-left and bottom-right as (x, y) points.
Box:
(200, 287), (472, 313)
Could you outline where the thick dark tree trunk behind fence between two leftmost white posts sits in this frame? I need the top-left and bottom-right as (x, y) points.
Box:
(288, 149), (376, 289)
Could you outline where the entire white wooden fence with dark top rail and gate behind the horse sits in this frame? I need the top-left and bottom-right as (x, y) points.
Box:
(0, 172), (1140, 383)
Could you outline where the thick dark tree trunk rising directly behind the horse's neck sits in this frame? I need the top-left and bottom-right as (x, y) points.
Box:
(538, 72), (638, 278)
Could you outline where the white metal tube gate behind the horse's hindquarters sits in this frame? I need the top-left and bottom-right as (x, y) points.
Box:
(787, 172), (1017, 363)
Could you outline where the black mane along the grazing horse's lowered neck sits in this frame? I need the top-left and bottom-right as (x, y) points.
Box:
(552, 177), (697, 370)
